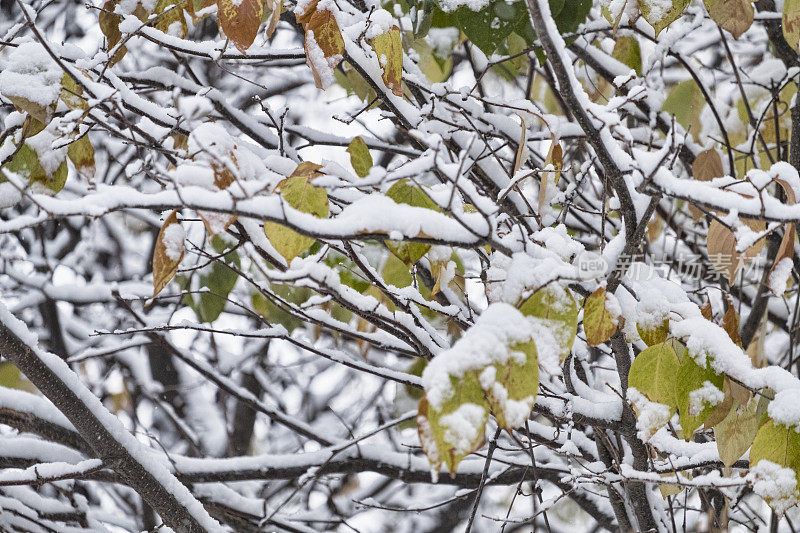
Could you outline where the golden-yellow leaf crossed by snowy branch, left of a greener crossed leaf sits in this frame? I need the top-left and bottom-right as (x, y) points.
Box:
(264, 162), (330, 264)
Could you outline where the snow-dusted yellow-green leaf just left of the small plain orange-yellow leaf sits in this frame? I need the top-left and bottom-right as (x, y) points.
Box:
(519, 284), (578, 361)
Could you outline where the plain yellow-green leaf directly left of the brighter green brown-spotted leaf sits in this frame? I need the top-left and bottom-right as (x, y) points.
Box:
(628, 342), (680, 408)
